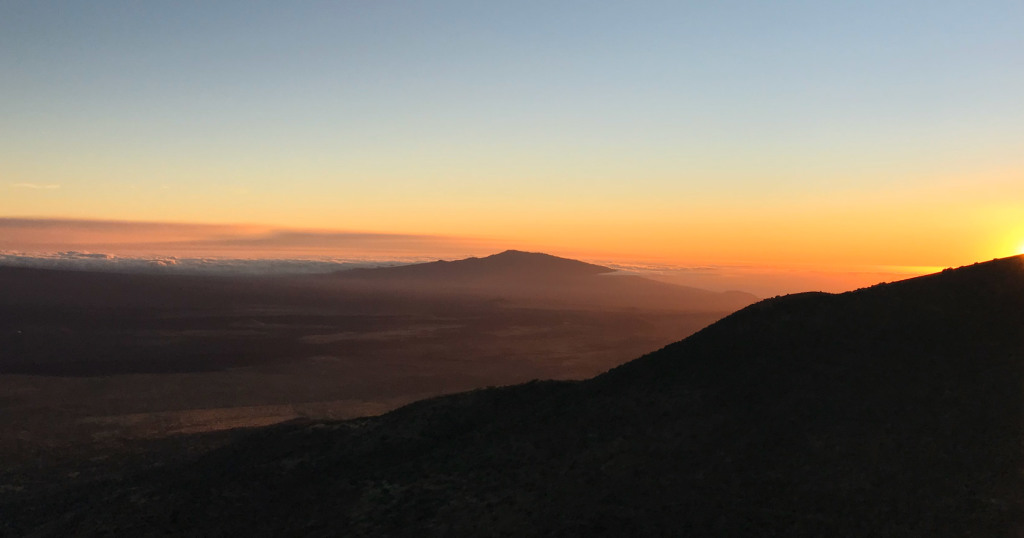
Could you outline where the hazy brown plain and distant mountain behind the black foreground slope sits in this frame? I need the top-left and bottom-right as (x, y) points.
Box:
(0, 251), (755, 468)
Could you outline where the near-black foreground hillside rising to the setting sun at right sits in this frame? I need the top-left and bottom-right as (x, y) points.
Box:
(0, 257), (1024, 537)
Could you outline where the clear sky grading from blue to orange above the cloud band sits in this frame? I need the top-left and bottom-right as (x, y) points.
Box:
(0, 0), (1024, 267)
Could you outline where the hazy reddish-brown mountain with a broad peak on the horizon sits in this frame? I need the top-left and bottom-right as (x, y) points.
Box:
(332, 250), (757, 313)
